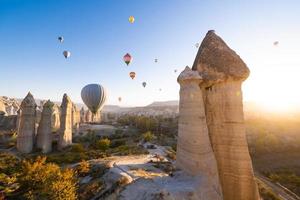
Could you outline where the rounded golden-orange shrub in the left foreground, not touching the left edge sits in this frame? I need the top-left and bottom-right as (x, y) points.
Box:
(18, 157), (77, 200)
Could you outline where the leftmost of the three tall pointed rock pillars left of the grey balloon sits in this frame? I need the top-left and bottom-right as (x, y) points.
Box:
(17, 92), (36, 153)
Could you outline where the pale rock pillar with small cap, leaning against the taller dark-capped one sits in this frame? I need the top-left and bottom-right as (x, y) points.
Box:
(176, 67), (222, 200)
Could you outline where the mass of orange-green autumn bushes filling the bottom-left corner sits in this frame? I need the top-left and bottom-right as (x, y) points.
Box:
(0, 154), (77, 200)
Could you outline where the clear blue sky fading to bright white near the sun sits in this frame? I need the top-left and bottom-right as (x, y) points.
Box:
(0, 0), (300, 109)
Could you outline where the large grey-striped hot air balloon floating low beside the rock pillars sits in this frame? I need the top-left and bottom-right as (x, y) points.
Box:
(81, 84), (106, 114)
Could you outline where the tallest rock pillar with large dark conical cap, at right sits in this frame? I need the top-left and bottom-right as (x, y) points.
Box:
(193, 31), (259, 200)
